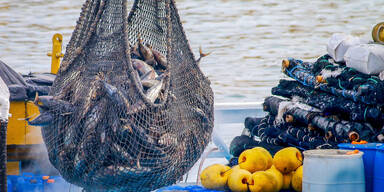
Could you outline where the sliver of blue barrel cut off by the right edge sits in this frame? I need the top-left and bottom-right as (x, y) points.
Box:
(373, 146), (384, 192)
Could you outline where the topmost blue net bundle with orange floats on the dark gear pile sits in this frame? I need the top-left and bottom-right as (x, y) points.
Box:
(283, 55), (384, 105)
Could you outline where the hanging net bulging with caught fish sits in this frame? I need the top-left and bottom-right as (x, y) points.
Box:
(32, 0), (213, 191)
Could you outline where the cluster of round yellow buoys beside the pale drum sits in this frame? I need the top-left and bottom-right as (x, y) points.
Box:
(200, 147), (303, 192)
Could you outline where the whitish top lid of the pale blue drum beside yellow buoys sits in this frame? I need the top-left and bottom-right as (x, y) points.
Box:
(303, 149), (364, 159)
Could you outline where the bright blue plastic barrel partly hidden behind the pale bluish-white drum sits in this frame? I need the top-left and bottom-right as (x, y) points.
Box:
(338, 143), (383, 192)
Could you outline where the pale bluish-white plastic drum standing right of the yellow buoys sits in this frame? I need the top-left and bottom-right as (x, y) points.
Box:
(303, 149), (365, 192)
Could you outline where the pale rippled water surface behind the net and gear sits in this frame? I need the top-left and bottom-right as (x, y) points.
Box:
(0, 0), (384, 102)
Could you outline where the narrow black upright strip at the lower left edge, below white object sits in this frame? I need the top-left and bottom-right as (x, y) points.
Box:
(0, 121), (8, 192)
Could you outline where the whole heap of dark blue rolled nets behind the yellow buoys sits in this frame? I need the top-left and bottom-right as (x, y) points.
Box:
(244, 55), (384, 150)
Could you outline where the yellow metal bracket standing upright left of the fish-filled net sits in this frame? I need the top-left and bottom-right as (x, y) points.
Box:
(47, 33), (64, 74)
